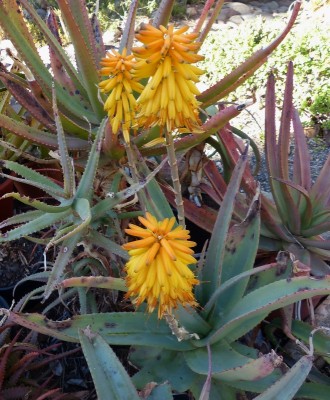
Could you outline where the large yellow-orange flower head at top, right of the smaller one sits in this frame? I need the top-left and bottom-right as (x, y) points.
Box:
(133, 25), (204, 132)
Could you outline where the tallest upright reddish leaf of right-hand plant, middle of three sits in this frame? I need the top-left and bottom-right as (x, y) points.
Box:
(277, 61), (293, 180)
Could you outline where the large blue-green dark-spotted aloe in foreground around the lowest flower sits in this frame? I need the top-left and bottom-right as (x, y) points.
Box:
(3, 151), (329, 399)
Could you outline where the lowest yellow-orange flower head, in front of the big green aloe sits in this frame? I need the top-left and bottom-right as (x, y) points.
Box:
(123, 213), (199, 318)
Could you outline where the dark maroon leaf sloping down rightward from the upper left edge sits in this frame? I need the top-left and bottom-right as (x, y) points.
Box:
(0, 67), (56, 133)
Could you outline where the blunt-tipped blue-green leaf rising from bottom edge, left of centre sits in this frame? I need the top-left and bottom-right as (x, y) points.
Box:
(79, 327), (140, 400)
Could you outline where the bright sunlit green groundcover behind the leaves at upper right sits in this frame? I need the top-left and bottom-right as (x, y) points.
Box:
(203, 17), (330, 122)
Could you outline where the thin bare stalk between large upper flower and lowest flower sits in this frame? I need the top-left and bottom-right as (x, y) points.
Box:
(165, 129), (186, 228)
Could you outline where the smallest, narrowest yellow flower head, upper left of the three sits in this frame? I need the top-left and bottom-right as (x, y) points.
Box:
(99, 49), (143, 143)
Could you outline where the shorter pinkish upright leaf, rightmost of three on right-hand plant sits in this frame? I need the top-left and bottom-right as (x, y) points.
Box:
(292, 108), (311, 190)
